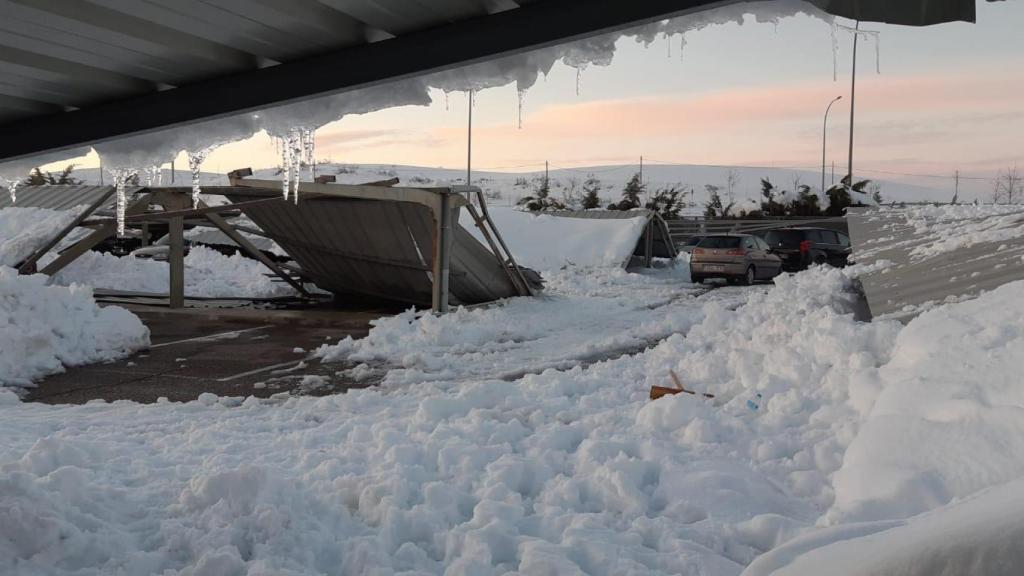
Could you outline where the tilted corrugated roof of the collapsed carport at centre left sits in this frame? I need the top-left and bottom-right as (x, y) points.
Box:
(227, 191), (517, 306)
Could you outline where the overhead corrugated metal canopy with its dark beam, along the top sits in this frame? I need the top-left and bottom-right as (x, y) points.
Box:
(0, 0), (991, 162)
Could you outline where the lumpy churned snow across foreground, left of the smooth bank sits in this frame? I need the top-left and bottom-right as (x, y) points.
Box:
(0, 271), (898, 576)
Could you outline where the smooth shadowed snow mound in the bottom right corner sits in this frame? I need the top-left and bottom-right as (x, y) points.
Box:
(743, 480), (1024, 576)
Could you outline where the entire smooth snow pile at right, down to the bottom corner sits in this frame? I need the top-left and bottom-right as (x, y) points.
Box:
(745, 282), (1024, 576)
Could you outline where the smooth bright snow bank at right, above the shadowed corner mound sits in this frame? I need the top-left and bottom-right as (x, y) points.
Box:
(827, 282), (1024, 523)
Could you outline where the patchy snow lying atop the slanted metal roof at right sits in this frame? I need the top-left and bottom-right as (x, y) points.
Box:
(856, 204), (1024, 261)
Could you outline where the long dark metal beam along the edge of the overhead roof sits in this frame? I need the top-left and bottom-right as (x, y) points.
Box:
(0, 0), (732, 161)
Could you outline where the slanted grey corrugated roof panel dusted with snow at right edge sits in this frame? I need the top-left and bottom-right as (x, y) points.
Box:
(849, 208), (1024, 321)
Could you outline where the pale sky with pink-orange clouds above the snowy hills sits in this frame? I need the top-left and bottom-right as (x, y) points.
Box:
(59, 1), (1024, 183)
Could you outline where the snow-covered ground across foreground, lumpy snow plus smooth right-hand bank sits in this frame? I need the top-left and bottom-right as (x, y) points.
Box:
(0, 258), (1024, 575)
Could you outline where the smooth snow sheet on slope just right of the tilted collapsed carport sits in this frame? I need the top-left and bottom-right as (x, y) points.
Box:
(463, 208), (647, 272)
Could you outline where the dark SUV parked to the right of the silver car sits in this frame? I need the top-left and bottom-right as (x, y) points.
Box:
(757, 228), (850, 272)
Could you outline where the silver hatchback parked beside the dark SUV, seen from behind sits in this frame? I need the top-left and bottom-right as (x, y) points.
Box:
(690, 234), (782, 285)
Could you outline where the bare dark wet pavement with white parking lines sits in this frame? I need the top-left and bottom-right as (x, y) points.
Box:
(25, 306), (393, 404)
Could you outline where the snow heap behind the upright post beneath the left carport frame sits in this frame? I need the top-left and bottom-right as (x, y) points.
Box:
(47, 246), (294, 298)
